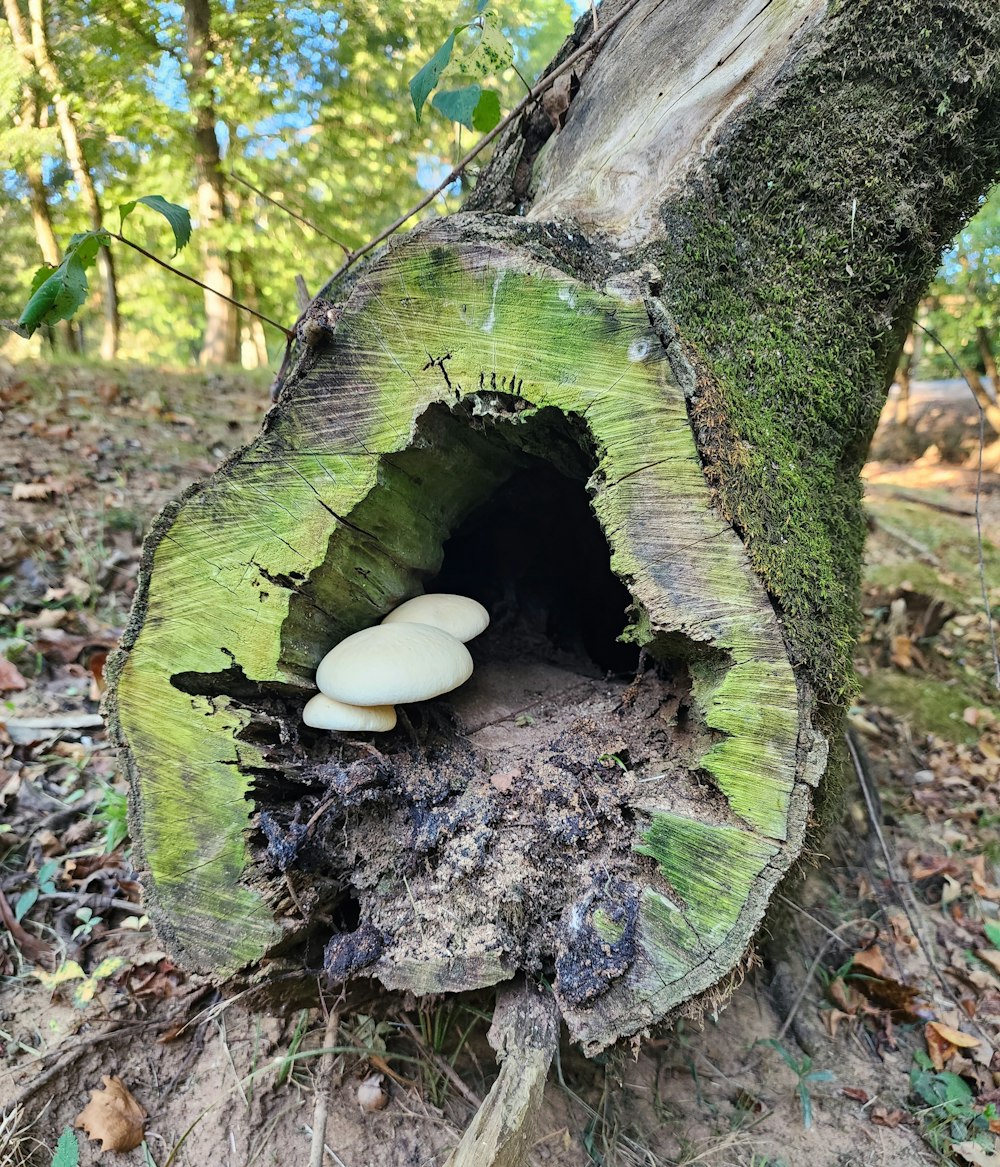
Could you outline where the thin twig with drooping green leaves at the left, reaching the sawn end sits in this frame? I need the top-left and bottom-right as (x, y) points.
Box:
(0, 195), (292, 337)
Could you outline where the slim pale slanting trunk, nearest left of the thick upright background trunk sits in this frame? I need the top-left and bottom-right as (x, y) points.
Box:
(21, 0), (120, 361)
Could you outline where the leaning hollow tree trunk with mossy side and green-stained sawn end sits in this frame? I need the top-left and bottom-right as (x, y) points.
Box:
(110, 0), (1000, 1068)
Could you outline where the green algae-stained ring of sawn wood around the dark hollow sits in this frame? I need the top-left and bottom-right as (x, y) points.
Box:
(111, 228), (812, 1049)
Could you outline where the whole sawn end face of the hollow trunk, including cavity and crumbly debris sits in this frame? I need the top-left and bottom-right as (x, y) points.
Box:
(110, 228), (824, 1053)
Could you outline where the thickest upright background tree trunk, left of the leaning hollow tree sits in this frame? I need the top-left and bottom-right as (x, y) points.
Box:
(184, 0), (239, 365)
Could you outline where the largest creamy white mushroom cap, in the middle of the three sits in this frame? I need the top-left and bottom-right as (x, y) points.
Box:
(316, 623), (473, 705)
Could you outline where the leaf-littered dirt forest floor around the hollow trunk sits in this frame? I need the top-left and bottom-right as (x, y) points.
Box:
(0, 362), (1000, 1167)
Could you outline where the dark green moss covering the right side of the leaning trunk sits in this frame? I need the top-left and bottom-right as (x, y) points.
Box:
(629, 0), (1000, 705)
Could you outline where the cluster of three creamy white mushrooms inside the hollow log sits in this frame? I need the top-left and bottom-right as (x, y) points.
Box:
(302, 594), (490, 733)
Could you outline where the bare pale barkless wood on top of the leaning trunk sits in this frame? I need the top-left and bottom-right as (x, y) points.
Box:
(529, 0), (826, 246)
